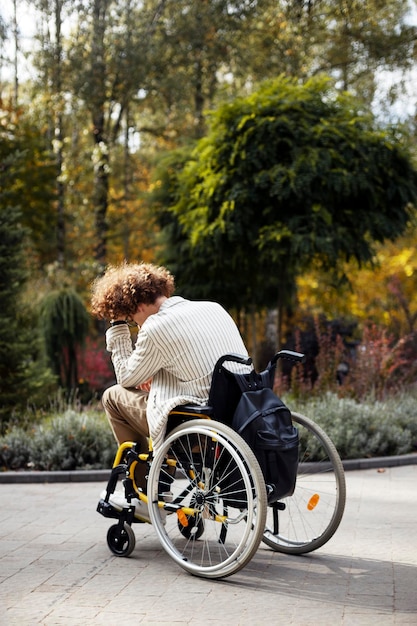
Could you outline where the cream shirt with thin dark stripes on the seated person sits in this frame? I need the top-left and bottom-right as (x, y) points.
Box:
(106, 296), (247, 448)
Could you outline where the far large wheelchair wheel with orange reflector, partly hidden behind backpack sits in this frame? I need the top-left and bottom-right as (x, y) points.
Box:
(263, 413), (346, 554)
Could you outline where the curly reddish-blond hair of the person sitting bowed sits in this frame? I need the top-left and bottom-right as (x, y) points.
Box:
(91, 262), (175, 320)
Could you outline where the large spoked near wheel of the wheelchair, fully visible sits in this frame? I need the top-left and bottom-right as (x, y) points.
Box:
(148, 419), (267, 578)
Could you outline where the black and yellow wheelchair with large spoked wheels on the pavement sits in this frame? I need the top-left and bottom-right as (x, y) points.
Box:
(97, 350), (346, 579)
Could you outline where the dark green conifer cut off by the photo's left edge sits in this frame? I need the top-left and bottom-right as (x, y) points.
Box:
(0, 122), (53, 431)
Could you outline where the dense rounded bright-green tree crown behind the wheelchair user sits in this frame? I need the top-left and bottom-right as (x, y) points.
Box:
(155, 77), (417, 344)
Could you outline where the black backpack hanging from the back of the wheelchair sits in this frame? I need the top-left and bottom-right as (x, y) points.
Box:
(232, 370), (299, 504)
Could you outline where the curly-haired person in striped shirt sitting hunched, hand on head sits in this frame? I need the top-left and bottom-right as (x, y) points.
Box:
(91, 263), (247, 521)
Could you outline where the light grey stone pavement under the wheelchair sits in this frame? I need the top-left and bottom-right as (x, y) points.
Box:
(0, 465), (417, 626)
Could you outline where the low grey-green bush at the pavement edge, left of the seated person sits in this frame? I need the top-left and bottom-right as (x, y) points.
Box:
(0, 409), (116, 470)
